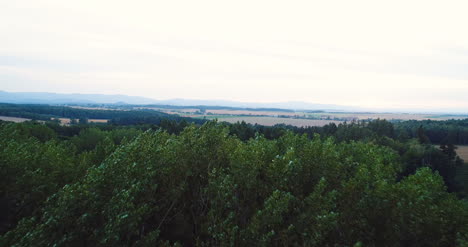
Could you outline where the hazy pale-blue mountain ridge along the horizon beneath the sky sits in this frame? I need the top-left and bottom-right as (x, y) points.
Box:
(0, 91), (359, 111)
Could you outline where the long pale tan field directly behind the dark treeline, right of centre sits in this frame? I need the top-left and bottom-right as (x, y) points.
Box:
(212, 116), (342, 127)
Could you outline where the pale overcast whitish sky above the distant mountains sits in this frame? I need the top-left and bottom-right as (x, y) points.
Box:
(0, 0), (468, 111)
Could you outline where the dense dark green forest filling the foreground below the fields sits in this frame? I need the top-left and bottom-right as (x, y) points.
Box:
(0, 116), (468, 246)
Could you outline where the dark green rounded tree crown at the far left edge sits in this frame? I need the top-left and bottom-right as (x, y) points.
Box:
(0, 124), (77, 232)
